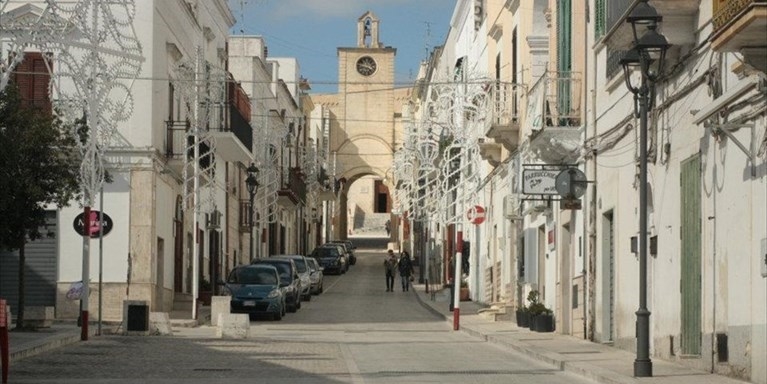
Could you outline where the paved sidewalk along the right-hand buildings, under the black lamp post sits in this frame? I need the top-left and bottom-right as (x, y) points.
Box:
(414, 284), (744, 384)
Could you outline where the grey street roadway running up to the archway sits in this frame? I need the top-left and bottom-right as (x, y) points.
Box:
(4, 238), (590, 384)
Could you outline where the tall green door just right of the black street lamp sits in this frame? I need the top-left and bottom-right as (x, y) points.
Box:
(680, 154), (702, 356)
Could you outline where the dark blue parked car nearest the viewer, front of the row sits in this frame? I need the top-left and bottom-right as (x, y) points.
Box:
(219, 265), (285, 320)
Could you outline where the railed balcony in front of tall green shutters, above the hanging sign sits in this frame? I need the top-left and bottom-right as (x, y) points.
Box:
(526, 72), (582, 164)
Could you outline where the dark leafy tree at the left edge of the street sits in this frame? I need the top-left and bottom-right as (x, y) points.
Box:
(0, 84), (80, 328)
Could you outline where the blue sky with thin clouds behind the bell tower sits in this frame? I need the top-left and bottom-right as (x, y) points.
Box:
(229, 0), (455, 93)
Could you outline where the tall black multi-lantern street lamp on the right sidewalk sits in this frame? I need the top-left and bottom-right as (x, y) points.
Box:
(621, 0), (670, 377)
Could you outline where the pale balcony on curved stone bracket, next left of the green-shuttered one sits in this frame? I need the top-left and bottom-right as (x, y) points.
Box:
(485, 81), (524, 151)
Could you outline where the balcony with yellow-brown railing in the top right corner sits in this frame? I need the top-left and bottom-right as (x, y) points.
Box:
(711, 0), (767, 72)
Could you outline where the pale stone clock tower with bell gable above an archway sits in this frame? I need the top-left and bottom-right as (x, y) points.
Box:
(312, 12), (412, 239)
